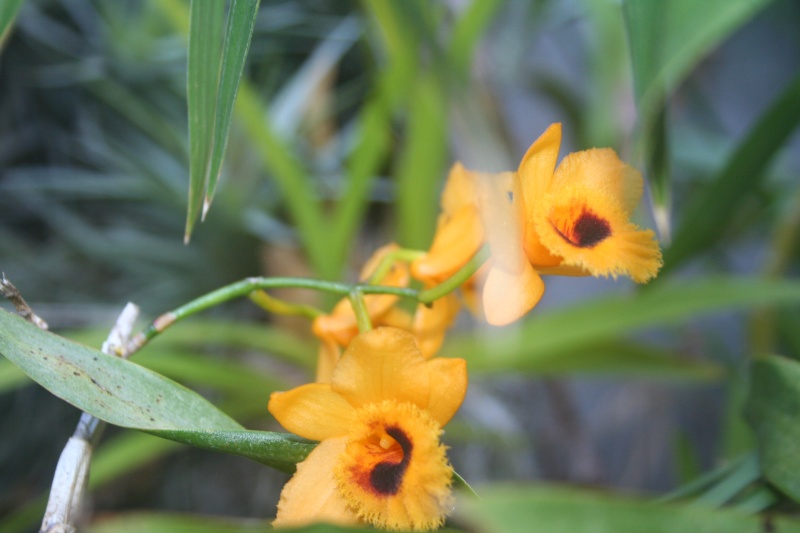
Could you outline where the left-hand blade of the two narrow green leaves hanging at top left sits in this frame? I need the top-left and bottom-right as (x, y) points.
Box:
(184, 0), (225, 242)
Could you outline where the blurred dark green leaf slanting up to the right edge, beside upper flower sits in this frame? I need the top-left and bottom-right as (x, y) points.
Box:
(661, 76), (800, 276)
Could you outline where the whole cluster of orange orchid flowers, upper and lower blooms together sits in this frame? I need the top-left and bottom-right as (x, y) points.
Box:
(269, 124), (661, 530)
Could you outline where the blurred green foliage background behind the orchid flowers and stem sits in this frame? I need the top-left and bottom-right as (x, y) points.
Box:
(0, 0), (800, 531)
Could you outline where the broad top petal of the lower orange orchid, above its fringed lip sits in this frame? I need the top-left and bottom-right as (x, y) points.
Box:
(331, 327), (430, 408)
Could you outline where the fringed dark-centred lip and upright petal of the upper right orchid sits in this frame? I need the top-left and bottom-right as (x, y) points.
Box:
(517, 124), (662, 283)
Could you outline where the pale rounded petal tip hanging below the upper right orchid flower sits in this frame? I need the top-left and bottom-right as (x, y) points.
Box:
(482, 262), (544, 326)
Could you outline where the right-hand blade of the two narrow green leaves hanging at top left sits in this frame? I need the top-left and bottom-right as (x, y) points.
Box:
(203, 0), (259, 212)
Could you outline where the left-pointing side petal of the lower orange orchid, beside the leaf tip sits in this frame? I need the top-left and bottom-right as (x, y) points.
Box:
(268, 382), (355, 440)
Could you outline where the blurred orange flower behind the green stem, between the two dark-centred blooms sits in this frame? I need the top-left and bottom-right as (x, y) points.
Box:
(312, 244), (460, 382)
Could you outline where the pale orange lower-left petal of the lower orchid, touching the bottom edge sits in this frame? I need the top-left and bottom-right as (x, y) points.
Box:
(272, 437), (361, 527)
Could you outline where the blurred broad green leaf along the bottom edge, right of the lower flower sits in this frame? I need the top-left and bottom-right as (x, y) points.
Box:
(459, 486), (800, 533)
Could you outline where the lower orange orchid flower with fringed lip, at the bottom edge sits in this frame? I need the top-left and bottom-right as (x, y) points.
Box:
(269, 327), (467, 530)
